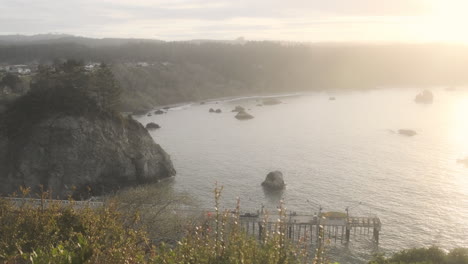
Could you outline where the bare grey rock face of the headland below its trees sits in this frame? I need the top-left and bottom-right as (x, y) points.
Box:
(0, 114), (175, 198)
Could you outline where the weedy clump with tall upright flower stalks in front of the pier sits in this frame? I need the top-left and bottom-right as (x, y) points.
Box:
(151, 186), (328, 264)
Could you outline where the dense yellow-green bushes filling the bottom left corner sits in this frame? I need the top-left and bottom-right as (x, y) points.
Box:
(0, 189), (150, 263)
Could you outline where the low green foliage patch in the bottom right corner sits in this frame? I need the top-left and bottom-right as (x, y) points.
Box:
(369, 247), (468, 264)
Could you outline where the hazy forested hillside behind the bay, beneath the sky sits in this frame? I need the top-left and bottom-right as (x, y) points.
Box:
(0, 38), (468, 110)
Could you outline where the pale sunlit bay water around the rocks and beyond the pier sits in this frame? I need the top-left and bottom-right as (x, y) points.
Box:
(137, 88), (468, 263)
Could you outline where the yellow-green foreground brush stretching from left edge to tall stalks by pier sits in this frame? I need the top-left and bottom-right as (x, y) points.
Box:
(0, 189), (336, 264)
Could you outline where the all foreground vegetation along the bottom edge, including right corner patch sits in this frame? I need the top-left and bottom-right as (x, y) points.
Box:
(6, 186), (468, 264)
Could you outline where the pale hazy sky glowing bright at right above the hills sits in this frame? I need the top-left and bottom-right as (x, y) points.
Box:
(0, 0), (468, 43)
